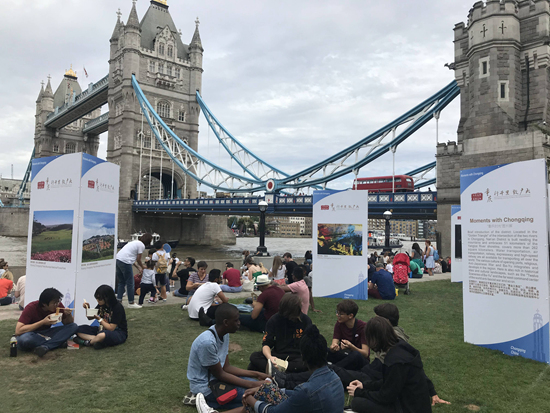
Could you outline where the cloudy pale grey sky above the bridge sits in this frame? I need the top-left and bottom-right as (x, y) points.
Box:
(0, 0), (474, 189)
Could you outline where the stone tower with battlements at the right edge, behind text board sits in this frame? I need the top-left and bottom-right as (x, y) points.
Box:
(436, 0), (550, 255)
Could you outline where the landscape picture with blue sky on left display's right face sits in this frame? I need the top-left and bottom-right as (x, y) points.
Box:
(82, 211), (115, 262)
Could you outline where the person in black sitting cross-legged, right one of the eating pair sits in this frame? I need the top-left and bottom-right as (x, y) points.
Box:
(73, 284), (128, 350)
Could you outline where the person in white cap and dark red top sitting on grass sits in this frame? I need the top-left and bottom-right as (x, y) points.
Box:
(239, 275), (285, 333)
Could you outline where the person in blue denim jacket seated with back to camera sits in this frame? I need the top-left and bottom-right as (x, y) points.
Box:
(229, 325), (344, 413)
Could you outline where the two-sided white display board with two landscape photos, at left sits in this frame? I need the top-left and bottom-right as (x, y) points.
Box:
(25, 153), (120, 324)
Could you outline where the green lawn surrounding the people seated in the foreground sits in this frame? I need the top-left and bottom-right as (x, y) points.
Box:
(0, 281), (550, 413)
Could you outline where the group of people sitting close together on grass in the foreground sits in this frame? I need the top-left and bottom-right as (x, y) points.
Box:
(183, 296), (448, 413)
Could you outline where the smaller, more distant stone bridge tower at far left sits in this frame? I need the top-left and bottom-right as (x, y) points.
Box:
(34, 66), (101, 158)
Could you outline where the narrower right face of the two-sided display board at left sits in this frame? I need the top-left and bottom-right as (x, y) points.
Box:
(75, 154), (120, 324)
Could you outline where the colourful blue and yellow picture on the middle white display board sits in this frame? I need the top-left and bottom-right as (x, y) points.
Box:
(317, 224), (363, 255)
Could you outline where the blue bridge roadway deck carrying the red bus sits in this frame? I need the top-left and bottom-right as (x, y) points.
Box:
(132, 192), (437, 219)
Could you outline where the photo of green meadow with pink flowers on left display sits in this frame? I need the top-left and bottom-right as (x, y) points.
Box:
(31, 210), (74, 263)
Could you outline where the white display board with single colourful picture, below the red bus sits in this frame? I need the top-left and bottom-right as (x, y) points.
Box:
(312, 190), (368, 300)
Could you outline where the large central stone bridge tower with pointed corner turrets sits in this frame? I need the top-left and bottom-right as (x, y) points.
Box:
(107, 0), (203, 237)
